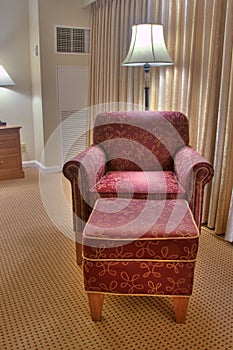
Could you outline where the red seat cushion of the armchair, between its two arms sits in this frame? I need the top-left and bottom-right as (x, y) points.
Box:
(90, 171), (186, 200)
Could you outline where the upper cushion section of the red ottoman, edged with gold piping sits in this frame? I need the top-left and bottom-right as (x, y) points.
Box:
(83, 198), (199, 261)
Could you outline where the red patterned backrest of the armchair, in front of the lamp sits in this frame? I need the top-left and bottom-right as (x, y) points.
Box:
(93, 111), (189, 171)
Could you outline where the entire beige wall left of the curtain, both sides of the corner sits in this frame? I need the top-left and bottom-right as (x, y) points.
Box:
(0, 0), (90, 162)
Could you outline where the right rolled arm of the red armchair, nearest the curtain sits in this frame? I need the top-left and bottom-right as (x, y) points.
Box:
(174, 147), (214, 229)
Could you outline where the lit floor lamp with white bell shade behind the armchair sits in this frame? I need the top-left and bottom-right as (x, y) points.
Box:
(122, 24), (173, 109)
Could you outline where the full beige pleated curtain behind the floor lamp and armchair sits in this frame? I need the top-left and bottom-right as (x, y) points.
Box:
(90, 0), (233, 234)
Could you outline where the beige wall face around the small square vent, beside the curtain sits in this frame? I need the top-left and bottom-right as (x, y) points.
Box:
(38, 0), (90, 152)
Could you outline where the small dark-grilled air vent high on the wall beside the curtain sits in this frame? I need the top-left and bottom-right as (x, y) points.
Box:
(56, 26), (90, 54)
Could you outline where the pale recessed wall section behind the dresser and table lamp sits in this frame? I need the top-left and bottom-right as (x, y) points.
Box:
(0, 0), (35, 159)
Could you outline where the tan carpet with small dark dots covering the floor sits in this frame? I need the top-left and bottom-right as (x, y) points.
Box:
(0, 168), (233, 350)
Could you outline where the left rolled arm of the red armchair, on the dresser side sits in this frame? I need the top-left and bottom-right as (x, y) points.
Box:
(63, 145), (106, 232)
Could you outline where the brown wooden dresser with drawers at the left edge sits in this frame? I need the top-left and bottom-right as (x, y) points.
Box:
(0, 125), (24, 180)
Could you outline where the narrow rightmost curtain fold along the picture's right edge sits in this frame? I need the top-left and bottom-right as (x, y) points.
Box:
(208, 1), (233, 235)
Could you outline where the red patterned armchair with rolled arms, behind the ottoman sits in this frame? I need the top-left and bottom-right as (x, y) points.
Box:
(63, 111), (214, 264)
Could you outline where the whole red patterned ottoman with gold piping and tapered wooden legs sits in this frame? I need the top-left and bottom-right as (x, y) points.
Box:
(83, 198), (199, 323)
